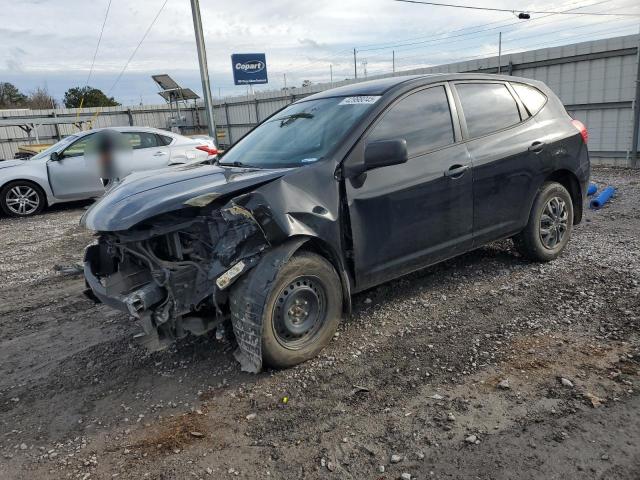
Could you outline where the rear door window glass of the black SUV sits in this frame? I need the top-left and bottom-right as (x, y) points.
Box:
(456, 83), (521, 138)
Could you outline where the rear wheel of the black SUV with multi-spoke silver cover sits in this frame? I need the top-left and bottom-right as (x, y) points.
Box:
(513, 182), (573, 262)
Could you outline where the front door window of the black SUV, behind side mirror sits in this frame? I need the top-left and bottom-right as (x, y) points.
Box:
(368, 87), (454, 157)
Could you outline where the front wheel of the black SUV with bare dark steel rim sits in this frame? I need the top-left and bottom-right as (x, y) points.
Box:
(229, 252), (343, 368)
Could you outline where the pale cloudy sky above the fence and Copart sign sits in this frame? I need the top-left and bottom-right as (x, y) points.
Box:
(0, 0), (640, 105)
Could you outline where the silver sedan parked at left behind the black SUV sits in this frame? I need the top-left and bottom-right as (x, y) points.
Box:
(0, 127), (217, 217)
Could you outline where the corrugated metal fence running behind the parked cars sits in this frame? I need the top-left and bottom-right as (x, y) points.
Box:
(0, 35), (640, 166)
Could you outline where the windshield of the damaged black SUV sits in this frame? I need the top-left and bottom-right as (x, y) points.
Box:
(219, 96), (380, 168)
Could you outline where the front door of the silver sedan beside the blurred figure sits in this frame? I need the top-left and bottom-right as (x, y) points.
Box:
(47, 134), (104, 200)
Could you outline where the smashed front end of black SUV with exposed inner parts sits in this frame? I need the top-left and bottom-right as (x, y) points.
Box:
(84, 199), (269, 350)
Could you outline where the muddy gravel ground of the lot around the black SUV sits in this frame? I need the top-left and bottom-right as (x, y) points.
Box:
(0, 168), (640, 480)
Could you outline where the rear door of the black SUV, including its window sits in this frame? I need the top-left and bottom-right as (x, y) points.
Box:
(454, 81), (544, 246)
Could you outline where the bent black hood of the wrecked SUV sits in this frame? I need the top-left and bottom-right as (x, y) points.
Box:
(80, 164), (290, 232)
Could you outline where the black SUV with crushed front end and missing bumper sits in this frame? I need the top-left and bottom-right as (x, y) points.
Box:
(82, 74), (590, 371)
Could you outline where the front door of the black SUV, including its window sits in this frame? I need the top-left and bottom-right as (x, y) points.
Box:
(346, 85), (473, 290)
